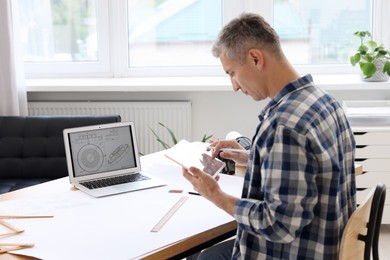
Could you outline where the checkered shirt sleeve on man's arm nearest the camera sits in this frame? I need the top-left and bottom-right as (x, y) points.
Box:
(235, 126), (318, 243)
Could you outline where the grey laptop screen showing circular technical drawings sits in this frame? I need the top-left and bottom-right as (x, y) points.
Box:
(68, 125), (137, 177)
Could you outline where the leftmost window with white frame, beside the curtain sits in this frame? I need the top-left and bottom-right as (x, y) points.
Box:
(13, 0), (111, 78)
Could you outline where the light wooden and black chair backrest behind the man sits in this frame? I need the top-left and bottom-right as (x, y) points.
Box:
(339, 183), (386, 260)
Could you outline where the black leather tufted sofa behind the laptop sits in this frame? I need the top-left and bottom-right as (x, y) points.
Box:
(0, 115), (121, 194)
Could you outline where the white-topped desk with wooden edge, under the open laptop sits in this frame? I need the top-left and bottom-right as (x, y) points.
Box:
(0, 149), (243, 259)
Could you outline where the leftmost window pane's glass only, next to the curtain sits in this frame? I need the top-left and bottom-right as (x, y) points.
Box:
(17, 0), (98, 62)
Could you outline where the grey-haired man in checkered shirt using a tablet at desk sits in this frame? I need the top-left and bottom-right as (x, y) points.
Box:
(183, 14), (356, 259)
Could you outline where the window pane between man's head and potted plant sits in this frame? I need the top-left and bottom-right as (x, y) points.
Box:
(274, 0), (372, 65)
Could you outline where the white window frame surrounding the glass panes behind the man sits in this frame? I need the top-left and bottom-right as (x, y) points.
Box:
(21, 0), (390, 78)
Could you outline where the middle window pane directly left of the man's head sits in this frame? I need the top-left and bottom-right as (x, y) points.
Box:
(128, 0), (223, 69)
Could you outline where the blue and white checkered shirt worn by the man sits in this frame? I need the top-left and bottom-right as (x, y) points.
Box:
(233, 75), (356, 259)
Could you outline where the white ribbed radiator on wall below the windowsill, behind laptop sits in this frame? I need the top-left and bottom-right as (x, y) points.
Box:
(28, 101), (191, 154)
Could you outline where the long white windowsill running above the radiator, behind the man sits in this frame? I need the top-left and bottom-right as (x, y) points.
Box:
(26, 74), (390, 92)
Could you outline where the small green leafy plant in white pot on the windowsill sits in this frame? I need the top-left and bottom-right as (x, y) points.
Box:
(350, 31), (390, 81)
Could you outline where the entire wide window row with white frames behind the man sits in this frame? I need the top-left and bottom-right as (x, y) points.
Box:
(16, 0), (390, 77)
